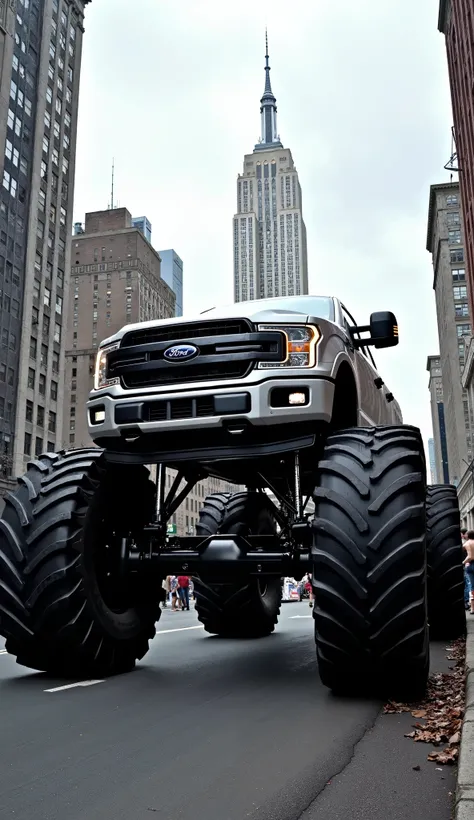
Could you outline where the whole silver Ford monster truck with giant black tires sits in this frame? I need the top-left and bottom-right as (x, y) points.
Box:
(0, 296), (464, 698)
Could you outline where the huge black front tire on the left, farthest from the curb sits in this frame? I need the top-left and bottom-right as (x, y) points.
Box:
(0, 448), (161, 678)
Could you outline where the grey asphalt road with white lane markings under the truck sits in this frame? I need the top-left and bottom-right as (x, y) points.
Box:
(0, 603), (455, 820)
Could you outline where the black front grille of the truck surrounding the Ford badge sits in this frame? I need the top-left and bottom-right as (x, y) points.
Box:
(107, 319), (286, 390)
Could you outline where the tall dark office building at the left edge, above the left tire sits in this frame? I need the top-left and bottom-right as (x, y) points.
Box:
(0, 0), (90, 480)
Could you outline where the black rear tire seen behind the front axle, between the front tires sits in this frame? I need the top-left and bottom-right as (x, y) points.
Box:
(194, 493), (282, 638)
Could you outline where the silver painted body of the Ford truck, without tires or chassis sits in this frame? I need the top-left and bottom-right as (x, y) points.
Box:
(87, 296), (402, 446)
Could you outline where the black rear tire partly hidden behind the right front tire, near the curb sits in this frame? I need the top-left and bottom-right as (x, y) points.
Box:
(426, 484), (466, 640)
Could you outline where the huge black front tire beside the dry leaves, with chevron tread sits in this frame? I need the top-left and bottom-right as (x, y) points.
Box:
(312, 425), (429, 701)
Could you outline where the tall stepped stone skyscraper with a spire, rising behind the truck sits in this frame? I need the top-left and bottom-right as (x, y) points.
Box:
(234, 34), (308, 302)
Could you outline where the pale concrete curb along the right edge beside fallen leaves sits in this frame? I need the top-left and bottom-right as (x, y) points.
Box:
(454, 618), (474, 820)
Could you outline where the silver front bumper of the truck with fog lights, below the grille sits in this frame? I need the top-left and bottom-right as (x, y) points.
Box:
(87, 376), (334, 446)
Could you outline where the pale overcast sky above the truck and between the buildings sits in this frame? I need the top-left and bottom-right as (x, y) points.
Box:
(75, 0), (452, 448)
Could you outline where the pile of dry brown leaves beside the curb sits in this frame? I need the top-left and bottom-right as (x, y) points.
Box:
(384, 639), (466, 764)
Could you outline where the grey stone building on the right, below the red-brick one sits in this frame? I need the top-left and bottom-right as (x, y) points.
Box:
(426, 182), (474, 484)
